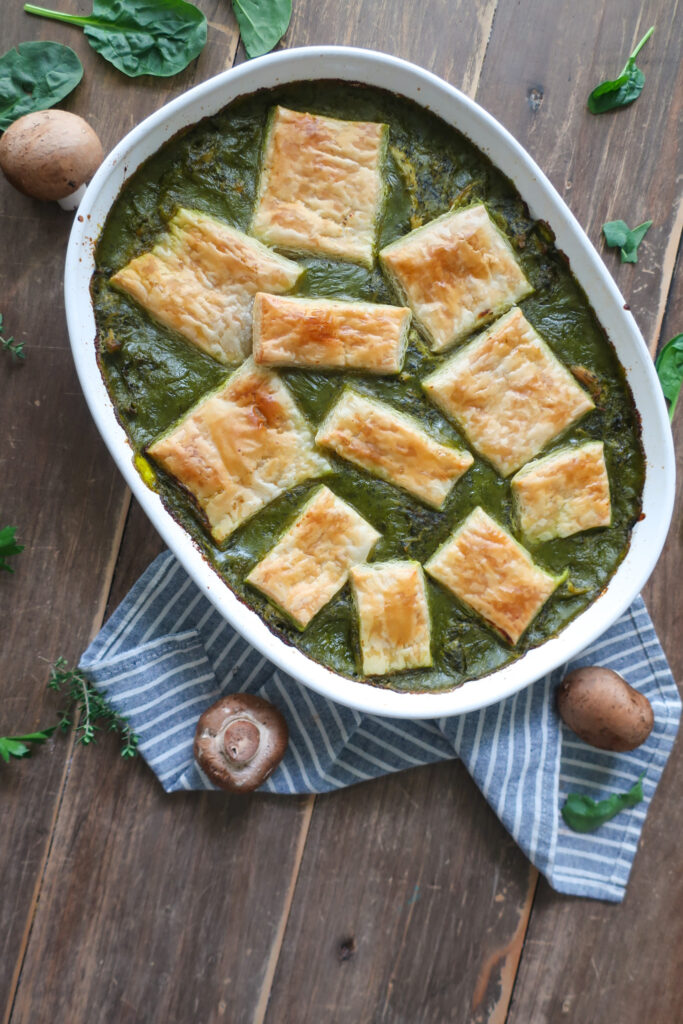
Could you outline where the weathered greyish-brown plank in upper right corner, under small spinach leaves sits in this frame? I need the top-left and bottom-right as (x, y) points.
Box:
(476, 0), (683, 341)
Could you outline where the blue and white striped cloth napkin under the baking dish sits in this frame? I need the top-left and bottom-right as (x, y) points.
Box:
(81, 553), (681, 902)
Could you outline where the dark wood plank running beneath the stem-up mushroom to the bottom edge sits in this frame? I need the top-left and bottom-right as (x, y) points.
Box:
(11, 497), (312, 1024)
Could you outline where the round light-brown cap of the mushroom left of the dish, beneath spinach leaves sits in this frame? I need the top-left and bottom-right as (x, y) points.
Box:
(0, 111), (103, 200)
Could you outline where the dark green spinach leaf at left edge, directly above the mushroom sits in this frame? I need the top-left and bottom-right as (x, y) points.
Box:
(0, 41), (83, 131)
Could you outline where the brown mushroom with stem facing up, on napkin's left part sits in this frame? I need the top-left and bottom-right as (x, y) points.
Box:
(195, 693), (289, 793)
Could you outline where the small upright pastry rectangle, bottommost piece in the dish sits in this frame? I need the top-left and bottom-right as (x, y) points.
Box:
(349, 561), (432, 676)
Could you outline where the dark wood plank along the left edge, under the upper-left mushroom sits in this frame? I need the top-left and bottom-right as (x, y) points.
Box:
(0, 0), (238, 1013)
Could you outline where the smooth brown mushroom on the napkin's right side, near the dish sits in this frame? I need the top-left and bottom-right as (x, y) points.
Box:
(557, 666), (654, 751)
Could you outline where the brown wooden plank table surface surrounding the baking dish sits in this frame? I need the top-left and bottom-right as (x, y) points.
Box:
(0, 0), (683, 1024)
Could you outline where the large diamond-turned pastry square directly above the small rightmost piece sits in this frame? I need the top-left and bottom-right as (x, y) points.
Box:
(422, 308), (594, 476)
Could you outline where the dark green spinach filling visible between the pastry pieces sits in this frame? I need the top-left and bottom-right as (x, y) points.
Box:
(91, 82), (644, 690)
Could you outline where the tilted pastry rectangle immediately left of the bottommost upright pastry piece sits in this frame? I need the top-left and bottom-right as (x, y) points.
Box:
(247, 486), (381, 630)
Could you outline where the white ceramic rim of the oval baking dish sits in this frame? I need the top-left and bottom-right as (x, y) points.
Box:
(65, 46), (675, 718)
